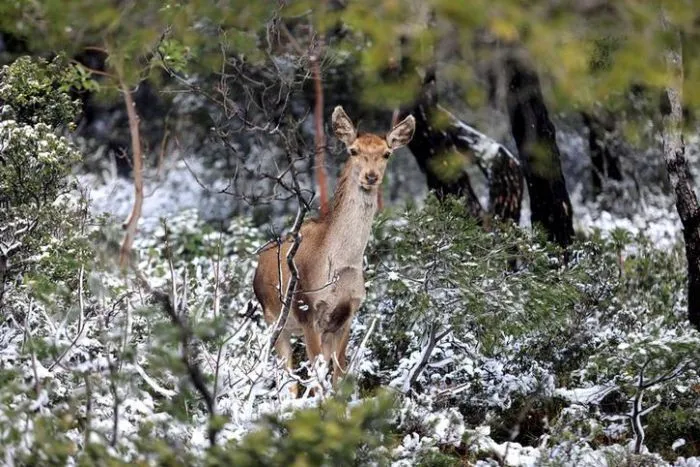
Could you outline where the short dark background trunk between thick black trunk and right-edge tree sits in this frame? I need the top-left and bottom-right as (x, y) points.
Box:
(581, 112), (622, 196)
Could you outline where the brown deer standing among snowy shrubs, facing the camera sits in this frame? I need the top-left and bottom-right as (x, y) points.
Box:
(253, 106), (416, 395)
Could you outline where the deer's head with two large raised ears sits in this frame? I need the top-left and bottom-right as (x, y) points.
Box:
(332, 106), (416, 192)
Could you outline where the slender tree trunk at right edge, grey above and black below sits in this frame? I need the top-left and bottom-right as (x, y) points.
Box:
(663, 22), (700, 329)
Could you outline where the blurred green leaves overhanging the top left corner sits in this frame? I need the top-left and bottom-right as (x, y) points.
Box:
(0, 0), (277, 88)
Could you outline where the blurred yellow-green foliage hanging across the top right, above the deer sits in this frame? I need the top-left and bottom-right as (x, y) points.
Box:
(290, 0), (700, 115)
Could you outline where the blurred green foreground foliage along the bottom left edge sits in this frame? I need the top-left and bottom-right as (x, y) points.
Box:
(0, 382), (393, 467)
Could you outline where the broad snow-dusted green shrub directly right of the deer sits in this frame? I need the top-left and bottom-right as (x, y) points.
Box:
(360, 196), (616, 396)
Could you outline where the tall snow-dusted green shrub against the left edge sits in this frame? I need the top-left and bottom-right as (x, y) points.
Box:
(0, 58), (85, 305)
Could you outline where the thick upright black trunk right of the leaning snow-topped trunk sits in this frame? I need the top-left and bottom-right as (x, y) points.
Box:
(506, 57), (574, 252)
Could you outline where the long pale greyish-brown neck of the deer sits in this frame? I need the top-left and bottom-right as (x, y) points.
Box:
(325, 164), (377, 269)
